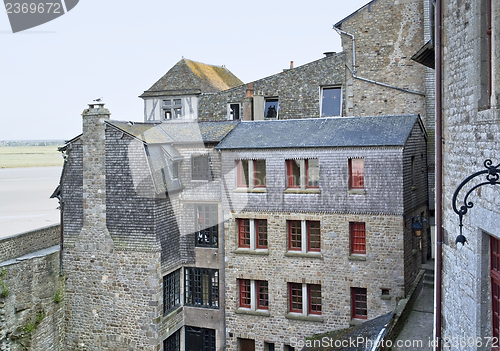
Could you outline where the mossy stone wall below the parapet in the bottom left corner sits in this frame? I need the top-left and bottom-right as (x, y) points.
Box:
(0, 249), (67, 351)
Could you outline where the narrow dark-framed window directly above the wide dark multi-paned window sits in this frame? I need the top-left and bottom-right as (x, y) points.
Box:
(195, 205), (219, 247)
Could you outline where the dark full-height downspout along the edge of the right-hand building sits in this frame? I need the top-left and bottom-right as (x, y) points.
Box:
(434, 0), (443, 351)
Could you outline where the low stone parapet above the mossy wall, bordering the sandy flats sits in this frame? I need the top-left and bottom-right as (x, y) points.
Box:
(0, 224), (61, 262)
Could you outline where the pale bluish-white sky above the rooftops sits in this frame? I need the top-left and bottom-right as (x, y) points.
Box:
(0, 0), (369, 140)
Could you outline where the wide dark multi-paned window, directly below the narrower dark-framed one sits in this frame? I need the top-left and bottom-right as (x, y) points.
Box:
(184, 267), (219, 308)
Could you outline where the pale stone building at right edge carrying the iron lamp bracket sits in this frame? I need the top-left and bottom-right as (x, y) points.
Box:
(437, 0), (500, 350)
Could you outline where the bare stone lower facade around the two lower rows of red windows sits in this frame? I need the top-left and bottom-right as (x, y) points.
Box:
(225, 212), (404, 350)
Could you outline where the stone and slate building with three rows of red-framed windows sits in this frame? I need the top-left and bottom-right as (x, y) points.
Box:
(216, 115), (428, 350)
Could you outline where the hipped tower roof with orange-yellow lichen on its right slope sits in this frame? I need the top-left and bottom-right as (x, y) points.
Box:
(140, 58), (243, 97)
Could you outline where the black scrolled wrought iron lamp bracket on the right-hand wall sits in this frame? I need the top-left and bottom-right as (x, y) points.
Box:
(452, 159), (500, 246)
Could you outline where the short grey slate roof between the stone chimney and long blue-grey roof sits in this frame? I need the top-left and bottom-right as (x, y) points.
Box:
(108, 121), (240, 144)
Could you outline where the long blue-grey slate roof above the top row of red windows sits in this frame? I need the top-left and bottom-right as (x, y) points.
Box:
(216, 115), (423, 149)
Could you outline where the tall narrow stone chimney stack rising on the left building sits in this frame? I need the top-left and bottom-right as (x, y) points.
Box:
(82, 102), (110, 227)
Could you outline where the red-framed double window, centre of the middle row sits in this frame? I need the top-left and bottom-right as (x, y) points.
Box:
(288, 221), (321, 253)
